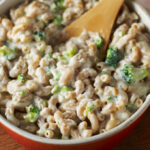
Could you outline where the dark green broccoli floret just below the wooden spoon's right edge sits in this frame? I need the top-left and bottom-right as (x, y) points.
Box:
(105, 47), (123, 67)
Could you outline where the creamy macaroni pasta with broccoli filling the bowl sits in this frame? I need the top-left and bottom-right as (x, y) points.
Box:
(0, 0), (150, 139)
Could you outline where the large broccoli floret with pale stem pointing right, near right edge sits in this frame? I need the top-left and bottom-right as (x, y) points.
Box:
(122, 65), (148, 84)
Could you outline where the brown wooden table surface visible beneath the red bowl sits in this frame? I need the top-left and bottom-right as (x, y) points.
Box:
(0, 109), (150, 150)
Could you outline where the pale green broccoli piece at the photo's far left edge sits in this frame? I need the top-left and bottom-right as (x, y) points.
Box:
(0, 45), (17, 60)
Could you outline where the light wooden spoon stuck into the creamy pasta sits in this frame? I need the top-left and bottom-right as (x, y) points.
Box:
(65, 0), (124, 56)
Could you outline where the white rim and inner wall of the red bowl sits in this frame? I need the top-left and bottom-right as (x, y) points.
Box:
(0, 0), (150, 145)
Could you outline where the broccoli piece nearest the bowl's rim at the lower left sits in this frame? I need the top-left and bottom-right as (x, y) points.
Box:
(24, 107), (40, 123)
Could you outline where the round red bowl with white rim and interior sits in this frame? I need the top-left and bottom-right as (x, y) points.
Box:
(0, 0), (150, 150)
